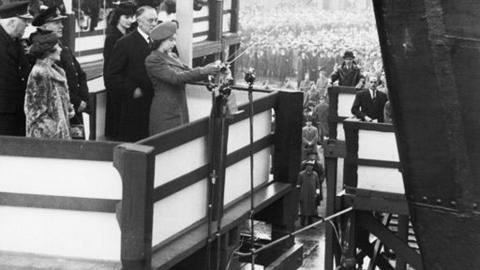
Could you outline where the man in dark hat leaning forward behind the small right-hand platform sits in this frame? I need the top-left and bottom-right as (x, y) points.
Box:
(328, 51), (364, 89)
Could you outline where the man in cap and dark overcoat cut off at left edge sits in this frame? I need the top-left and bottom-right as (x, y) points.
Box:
(0, 1), (33, 136)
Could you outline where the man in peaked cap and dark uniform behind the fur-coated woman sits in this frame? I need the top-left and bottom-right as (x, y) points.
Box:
(30, 6), (88, 139)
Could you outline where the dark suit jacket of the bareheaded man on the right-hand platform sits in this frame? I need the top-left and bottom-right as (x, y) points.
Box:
(352, 89), (388, 122)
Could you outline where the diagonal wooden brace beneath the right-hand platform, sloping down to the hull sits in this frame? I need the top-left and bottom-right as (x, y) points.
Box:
(357, 212), (423, 270)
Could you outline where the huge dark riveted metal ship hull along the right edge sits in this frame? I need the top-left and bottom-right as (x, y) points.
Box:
(374, 0), (480, 270)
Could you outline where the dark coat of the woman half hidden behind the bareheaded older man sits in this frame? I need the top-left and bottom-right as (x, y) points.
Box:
(103, 26), (123, 140)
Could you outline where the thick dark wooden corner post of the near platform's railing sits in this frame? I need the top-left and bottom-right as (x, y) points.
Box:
(114, 144), (155, 270)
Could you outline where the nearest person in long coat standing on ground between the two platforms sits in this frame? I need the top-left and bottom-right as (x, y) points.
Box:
(297, 160), (320, 226)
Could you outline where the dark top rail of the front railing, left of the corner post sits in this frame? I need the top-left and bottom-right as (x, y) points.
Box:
(0, 136), (119, 161)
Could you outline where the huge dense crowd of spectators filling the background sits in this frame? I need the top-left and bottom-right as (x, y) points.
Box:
(237, 1), (382, 89)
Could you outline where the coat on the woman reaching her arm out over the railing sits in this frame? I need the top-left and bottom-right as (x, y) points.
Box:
(145, 51), (206, 135)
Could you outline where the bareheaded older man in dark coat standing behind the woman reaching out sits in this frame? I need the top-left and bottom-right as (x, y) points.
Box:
(107, 6), (157, 142)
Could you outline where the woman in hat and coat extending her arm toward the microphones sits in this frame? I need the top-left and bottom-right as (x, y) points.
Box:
(145, 22), (220, 135)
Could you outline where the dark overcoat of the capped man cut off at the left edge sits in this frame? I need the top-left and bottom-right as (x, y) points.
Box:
(0, 26), (31, 136)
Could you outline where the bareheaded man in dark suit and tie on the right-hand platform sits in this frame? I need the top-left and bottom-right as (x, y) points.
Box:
(352, 75), (388, 122)
